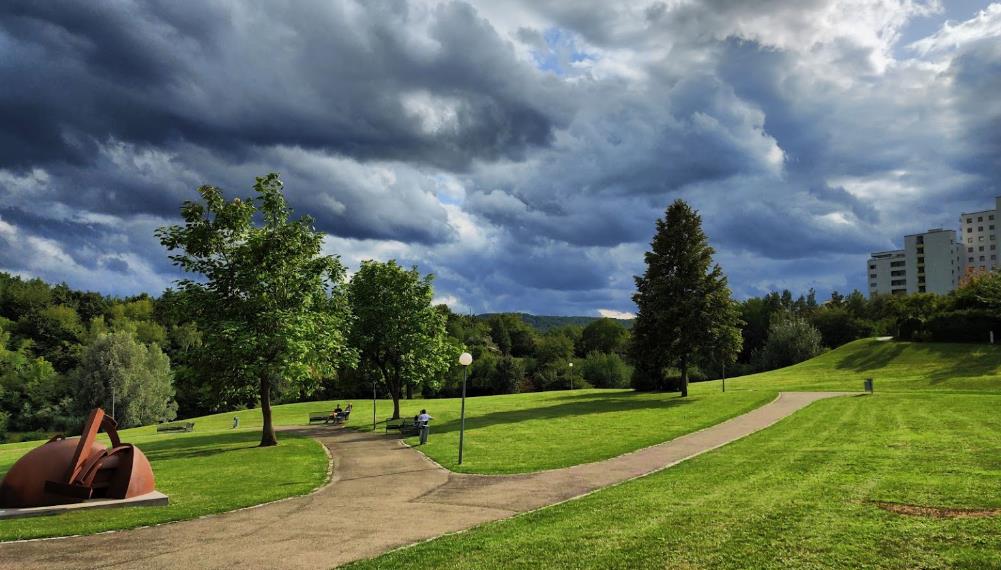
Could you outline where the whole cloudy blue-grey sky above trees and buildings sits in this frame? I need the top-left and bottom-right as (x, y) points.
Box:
(0, 0), (1001, 316)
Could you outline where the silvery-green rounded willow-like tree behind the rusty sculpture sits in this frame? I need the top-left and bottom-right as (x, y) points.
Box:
(73, 332), (177, 428)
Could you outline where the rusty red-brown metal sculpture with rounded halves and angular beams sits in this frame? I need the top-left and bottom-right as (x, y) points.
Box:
(0, 408), (155, 508)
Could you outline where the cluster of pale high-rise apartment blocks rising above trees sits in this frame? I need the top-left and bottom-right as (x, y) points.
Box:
(866, 196), (1001, 297)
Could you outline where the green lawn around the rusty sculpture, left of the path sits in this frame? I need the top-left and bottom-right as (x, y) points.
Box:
(0, 428), (327, 541)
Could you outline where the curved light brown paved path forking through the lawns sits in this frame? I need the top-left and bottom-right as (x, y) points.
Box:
(0, 392), (844, 568)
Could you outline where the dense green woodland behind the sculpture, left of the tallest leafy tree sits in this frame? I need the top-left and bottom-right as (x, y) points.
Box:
(0, 273), (184, 439)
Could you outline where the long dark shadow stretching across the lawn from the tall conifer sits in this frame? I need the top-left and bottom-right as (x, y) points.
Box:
(402, 394), (694, 435)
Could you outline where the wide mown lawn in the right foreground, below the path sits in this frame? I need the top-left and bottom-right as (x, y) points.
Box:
(354, 394), (1001, 568)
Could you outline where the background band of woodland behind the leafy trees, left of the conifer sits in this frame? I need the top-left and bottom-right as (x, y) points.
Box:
(0, 272), (631, 439)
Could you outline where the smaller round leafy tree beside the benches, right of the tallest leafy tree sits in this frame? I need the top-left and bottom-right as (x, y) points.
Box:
(347, 260), (458, 419)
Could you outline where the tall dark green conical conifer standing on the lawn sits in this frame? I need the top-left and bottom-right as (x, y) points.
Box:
(630, 199), (741, 397)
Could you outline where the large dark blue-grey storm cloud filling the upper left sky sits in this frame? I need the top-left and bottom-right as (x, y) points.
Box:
(0, 1), (566, 173)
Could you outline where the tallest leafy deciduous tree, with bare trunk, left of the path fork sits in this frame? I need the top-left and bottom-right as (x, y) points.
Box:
(157, 173), (356, 446)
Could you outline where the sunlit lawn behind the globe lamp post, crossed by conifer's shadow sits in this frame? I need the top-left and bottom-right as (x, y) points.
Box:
(366, 385), (777, 474)
